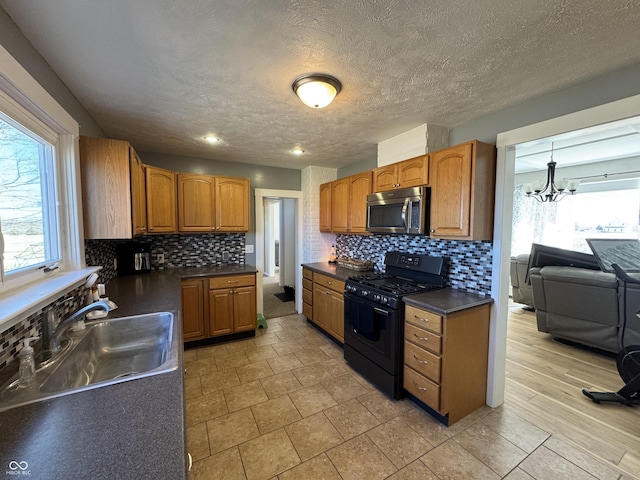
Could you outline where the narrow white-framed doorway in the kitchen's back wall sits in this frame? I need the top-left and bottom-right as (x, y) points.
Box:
(255, 188), (302, 318)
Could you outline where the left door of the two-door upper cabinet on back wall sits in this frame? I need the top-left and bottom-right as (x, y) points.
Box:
(178, 173), (215, 232)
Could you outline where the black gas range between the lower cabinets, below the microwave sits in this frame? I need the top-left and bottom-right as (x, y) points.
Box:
(344, 252), (446, 399)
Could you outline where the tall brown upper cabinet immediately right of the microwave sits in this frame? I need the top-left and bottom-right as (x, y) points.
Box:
(430, 140), (496, 240)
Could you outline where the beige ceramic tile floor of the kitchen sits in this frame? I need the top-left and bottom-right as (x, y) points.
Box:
(185, 315), (628, 480)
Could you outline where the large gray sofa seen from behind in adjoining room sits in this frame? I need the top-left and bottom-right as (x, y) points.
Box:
(529, 266), (640, 353)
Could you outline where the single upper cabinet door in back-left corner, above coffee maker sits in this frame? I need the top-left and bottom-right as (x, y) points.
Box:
(145, 165), (177, 233)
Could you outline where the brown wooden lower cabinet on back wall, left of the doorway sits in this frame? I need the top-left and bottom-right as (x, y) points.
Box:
(182, 274), (257, 342)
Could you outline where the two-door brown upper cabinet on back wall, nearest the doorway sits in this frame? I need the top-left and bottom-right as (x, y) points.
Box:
(178, 173), (249, 233)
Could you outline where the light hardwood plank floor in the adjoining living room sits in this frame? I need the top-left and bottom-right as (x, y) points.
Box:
(504, 304), (640, 475)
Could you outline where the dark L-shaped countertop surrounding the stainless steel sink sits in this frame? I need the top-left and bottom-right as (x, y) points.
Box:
(0, 265), (257, 480)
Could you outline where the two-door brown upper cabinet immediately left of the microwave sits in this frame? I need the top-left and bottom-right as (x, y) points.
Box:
(330, 171), (371, 233)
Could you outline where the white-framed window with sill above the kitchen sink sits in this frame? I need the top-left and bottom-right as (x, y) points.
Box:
(0, 46), (87, 332)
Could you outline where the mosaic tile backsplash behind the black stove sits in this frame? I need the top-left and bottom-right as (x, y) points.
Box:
(336, 235), (493, 295)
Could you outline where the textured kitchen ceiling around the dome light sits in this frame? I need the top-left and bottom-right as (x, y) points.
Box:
(0, 0), (640, 168)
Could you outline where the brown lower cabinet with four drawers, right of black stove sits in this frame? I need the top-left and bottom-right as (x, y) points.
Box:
(403, 305), (491, 425)
